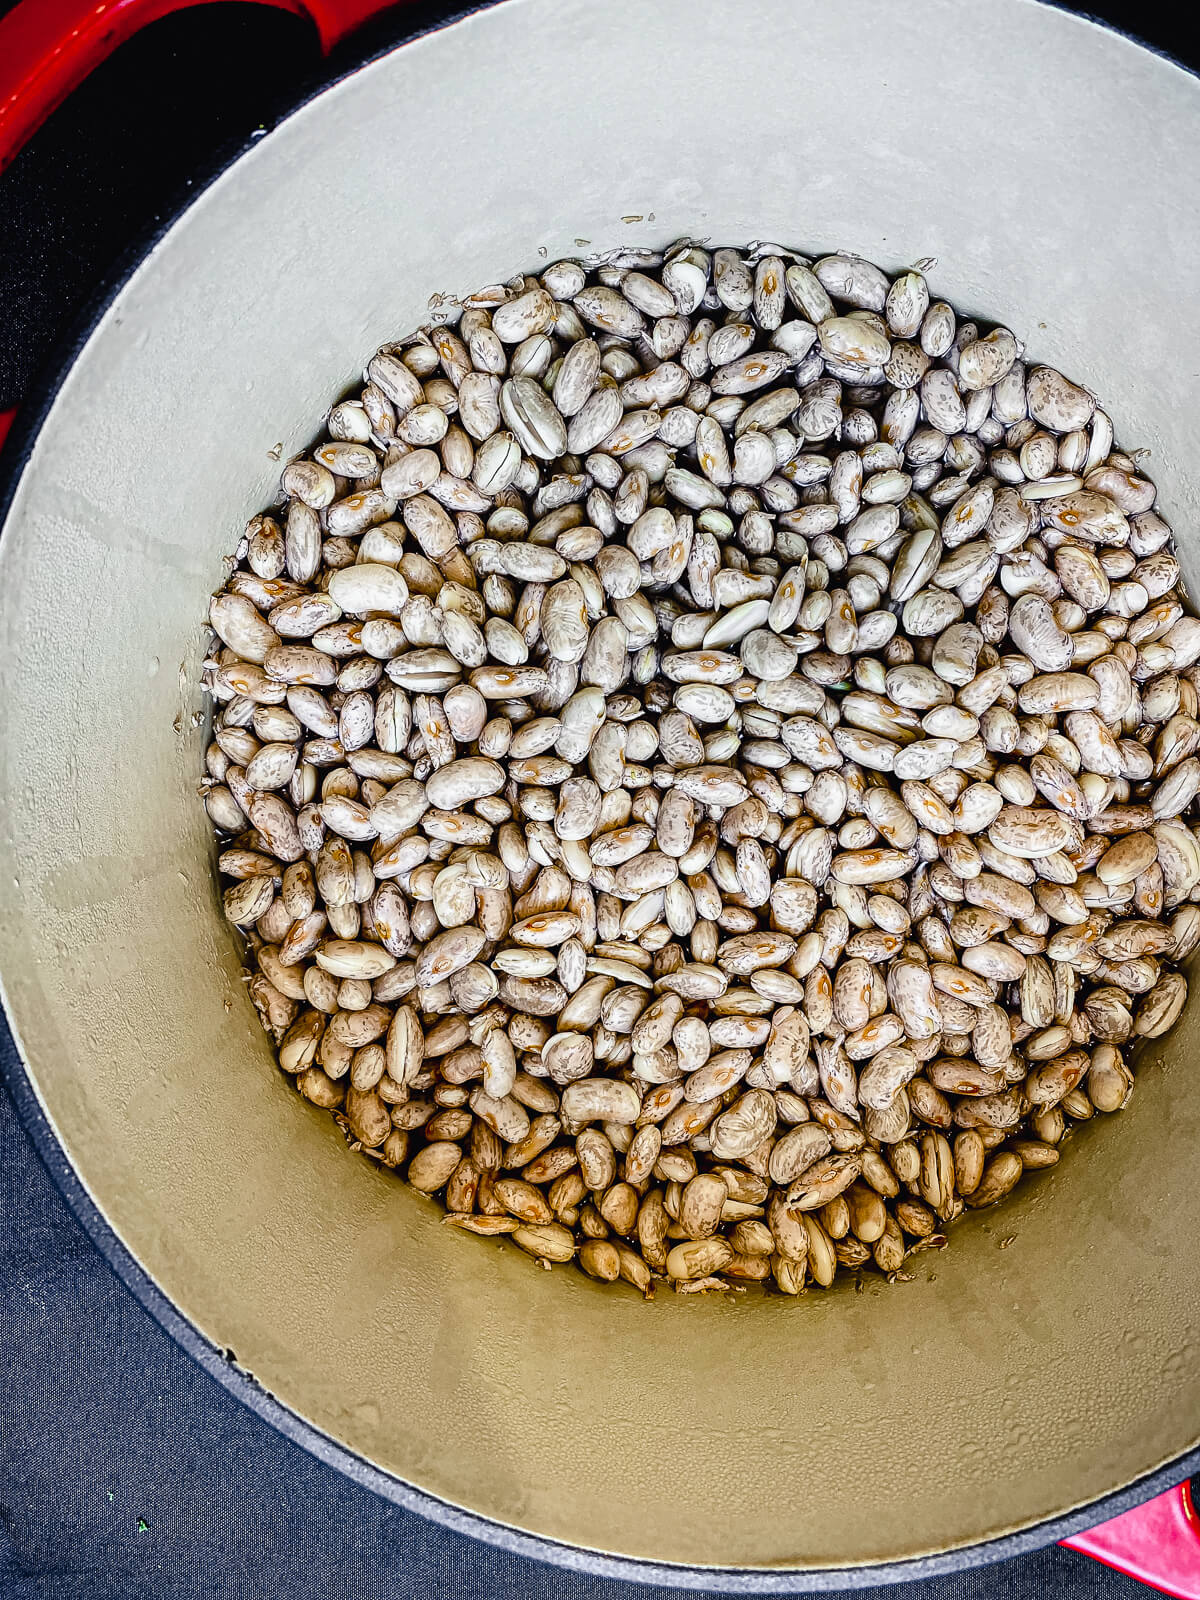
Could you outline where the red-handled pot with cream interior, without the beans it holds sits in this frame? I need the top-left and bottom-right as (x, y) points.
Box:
(0, 0), (1200, 1594)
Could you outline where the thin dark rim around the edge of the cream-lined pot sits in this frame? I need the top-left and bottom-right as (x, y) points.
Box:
(0, 0), (1200, 1594)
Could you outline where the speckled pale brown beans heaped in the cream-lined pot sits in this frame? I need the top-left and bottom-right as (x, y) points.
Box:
(203, 242), (1200, 1294)
